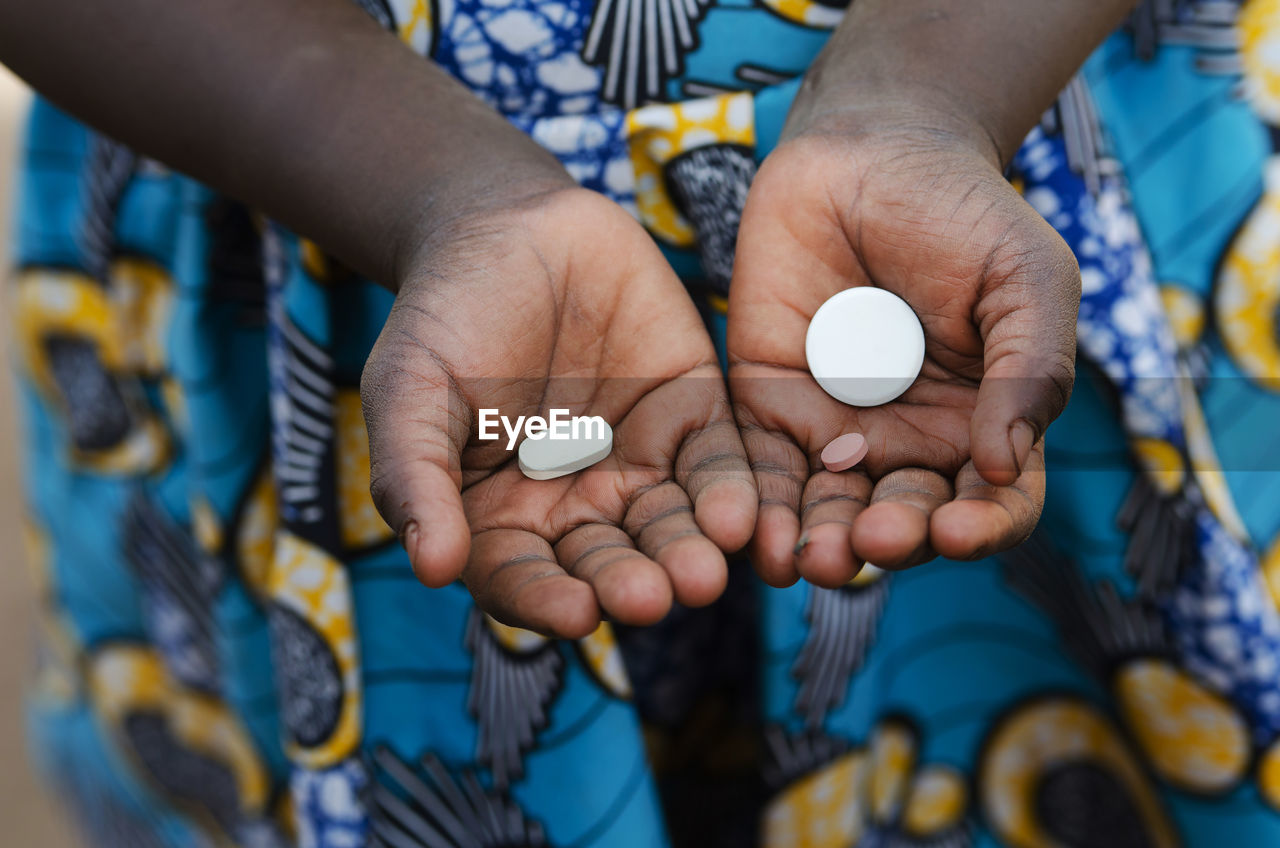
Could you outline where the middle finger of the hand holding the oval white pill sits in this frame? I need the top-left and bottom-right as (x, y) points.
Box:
(556, 524), (672, 625)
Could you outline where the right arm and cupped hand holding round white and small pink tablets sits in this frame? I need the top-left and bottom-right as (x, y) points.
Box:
(728, 0), (1132, 587)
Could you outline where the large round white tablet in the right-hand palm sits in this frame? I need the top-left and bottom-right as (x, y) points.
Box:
(804, 286), (924, 406)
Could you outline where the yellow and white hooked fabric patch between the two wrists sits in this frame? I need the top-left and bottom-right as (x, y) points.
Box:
(627, 92), (755, 247)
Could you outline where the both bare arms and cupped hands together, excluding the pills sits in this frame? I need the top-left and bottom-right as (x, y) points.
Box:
(0, 0), (1126, 637)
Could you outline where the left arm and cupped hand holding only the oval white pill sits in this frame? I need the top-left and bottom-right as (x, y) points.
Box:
(0, 0), (758, 638)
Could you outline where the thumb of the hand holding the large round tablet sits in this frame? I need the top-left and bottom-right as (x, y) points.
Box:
(969, 220), (1080, 485)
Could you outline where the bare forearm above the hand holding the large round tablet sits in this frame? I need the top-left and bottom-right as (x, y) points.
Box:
(788, 0), (1134, 165)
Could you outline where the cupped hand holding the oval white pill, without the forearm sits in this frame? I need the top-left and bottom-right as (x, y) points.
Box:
(361, 188), (758, 638)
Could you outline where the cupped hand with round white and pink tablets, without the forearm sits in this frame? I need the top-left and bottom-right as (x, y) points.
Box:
(728, 122), (1080, 587)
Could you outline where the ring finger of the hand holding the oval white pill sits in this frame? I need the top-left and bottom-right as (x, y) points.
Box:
(623, 480), (728, 606)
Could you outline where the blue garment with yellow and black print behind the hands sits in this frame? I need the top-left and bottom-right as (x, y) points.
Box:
(10, 0), (1280, 848)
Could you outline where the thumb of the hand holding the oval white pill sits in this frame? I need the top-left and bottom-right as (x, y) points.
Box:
(360, 320), (471, 587)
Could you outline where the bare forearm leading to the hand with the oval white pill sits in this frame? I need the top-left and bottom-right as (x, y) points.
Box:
(0, 0), (570, 284)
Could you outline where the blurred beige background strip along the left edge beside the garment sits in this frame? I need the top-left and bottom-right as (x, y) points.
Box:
(0, 67), (77, 848)
